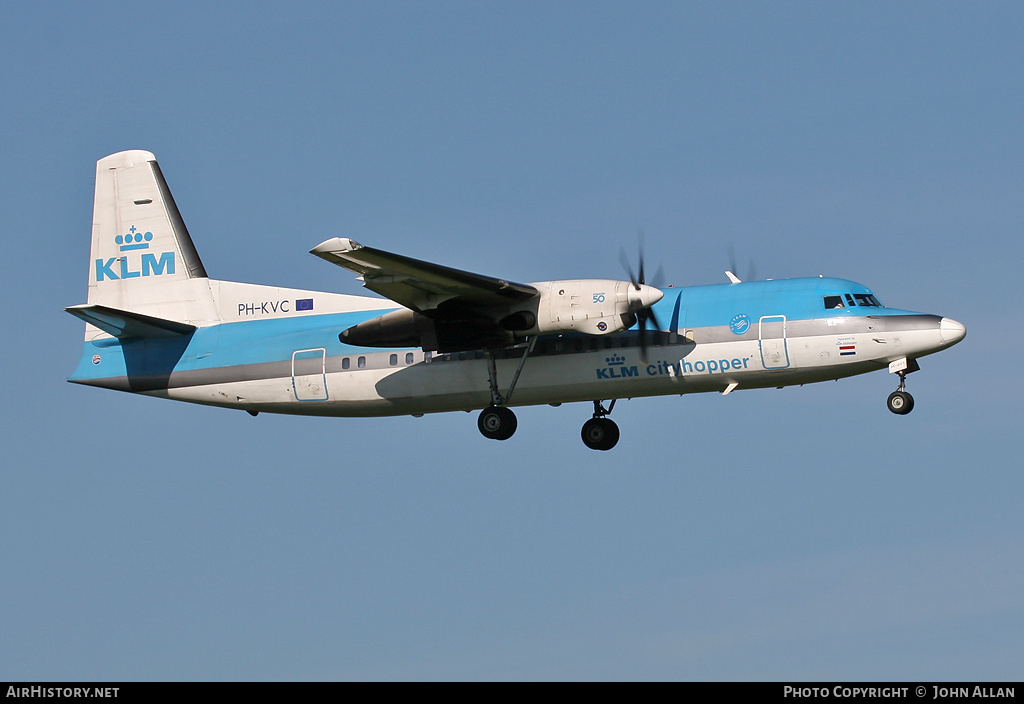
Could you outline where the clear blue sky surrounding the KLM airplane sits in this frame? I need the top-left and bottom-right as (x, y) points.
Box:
(0, 1), (1024, 680)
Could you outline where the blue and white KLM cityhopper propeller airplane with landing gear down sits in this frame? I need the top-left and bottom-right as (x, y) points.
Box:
(67, 149), (967, 450)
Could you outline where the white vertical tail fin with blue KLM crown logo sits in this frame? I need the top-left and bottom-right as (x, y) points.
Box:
(88, 149), (216, 320)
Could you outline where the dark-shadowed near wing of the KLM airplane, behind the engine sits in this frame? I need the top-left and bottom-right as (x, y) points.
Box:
(310, 237), (539, 313)
